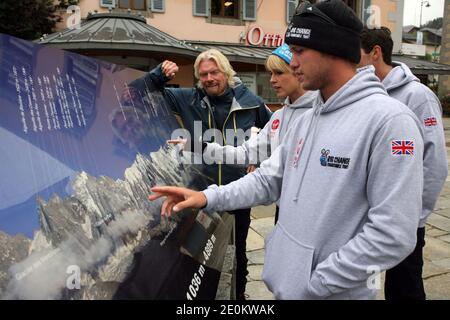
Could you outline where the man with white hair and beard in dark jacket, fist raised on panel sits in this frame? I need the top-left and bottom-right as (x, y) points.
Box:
(131, 49), (271, 299)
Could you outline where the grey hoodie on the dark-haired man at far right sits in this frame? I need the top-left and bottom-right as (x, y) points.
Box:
(383, 62), (448, 227)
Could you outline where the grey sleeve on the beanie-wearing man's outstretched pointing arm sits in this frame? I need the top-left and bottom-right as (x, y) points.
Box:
(203, 144), (286, 212)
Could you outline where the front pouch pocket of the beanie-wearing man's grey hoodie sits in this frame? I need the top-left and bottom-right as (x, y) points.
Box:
(262, 222), (314, 300)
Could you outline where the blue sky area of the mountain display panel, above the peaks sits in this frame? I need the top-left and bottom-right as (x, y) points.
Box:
(0, 35), (178, 238)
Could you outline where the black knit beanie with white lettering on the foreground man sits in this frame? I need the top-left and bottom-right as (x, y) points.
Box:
(285, 0), (363, 63)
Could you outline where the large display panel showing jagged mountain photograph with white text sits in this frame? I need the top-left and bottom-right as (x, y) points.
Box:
(0, 35), (233, 300)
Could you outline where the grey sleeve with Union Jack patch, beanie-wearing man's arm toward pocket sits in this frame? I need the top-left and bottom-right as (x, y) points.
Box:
(309, 113), (423, 298)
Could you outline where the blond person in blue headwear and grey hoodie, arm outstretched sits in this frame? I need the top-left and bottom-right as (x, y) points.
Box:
(168, 44), (317, 223)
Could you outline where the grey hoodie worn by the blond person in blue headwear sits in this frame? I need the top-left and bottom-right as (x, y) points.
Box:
(203, 91), (317, 165)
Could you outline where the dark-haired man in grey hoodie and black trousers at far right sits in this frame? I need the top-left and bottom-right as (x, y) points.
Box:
(360, 27), (448, 300)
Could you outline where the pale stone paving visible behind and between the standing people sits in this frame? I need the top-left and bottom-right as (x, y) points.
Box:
(246, 118), (450, 300)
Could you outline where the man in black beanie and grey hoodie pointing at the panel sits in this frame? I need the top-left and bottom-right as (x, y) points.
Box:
(149, 0), (423, 299)
